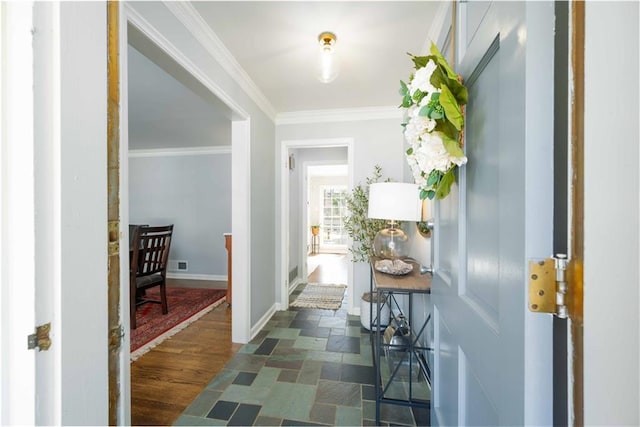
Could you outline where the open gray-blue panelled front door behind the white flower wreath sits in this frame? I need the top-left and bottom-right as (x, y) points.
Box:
(431, 2), (553, 425)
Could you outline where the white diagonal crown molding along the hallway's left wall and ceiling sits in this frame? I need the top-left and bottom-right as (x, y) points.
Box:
(164, 1), (276, 120)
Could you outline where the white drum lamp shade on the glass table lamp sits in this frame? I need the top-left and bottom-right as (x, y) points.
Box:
(368, 182), (422, 221)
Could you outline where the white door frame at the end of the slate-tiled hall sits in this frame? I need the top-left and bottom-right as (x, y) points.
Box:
(276, 138), (355, 314)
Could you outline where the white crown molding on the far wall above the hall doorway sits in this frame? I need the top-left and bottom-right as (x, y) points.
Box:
(276, 107), (403, 125)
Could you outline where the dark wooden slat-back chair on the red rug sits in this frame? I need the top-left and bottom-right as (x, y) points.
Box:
(129, 224), (173, 329)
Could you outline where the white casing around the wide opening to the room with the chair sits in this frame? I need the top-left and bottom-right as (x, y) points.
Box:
(119, 2), (251, 423)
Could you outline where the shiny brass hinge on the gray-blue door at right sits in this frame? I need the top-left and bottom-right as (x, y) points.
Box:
(529, 254), (569, 319)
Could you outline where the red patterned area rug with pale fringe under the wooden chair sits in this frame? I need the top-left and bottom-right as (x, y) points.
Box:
(131, 287), (227, 361)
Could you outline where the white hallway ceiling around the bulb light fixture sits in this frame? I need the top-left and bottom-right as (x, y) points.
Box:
(193, 1), (440, 113)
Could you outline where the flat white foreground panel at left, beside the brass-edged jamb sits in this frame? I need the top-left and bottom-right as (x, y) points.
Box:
(59, 2), (109, 425)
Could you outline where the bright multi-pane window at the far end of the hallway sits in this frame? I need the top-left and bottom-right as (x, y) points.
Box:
(320, 185), (348, 248)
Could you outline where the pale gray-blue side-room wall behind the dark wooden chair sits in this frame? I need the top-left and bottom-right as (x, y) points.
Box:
(129, 149), (231, 280)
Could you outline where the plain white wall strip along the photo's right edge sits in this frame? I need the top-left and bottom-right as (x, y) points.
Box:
(584, 2), (640, 425)
